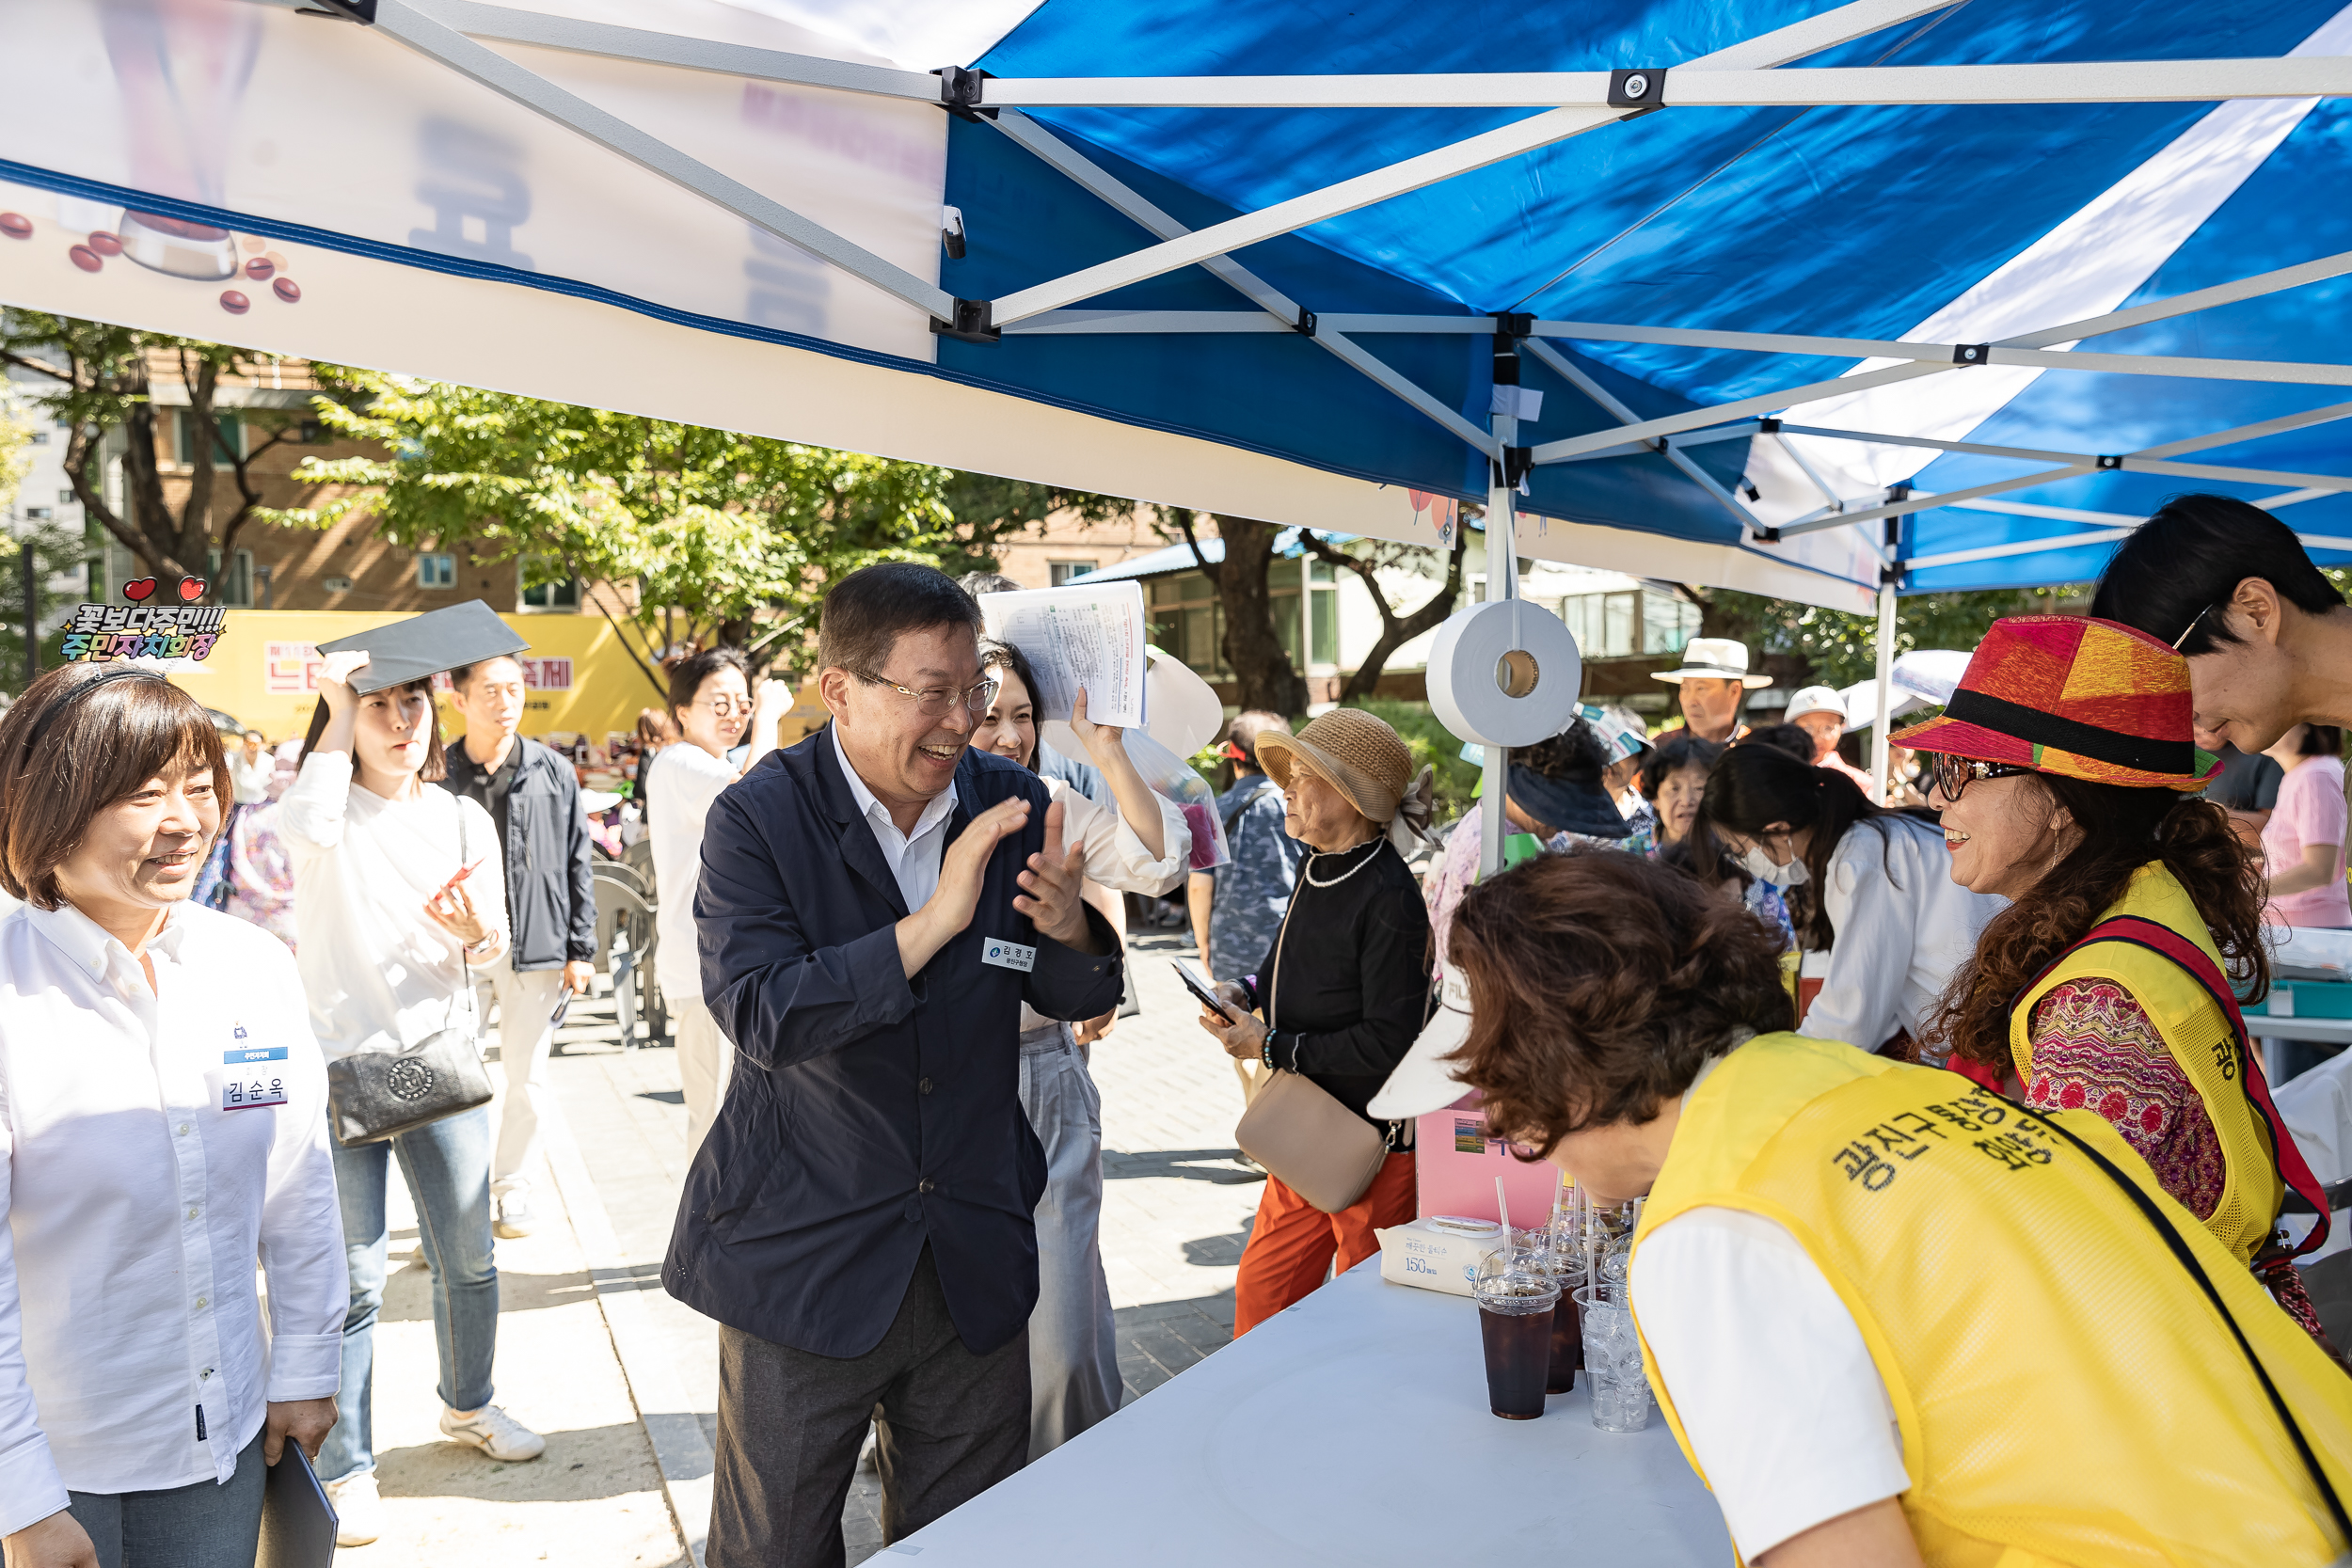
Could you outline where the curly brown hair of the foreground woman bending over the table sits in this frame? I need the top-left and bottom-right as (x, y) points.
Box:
(1447, 848), (1797, 1154)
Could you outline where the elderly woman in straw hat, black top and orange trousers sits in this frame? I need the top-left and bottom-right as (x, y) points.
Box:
(1200, 707), (1430, 1336)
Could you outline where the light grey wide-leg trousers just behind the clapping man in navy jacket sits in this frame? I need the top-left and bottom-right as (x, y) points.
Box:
(1021, 1022), (1120, 1460)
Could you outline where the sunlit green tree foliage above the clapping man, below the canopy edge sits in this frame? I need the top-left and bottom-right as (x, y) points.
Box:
(271, 367), (1030, 687)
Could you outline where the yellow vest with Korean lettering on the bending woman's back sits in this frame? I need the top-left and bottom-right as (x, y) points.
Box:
(1635, 1035), (2352, 1568)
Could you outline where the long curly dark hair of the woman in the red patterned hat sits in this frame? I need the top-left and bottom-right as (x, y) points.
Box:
(1922, 773), (2270, 1068)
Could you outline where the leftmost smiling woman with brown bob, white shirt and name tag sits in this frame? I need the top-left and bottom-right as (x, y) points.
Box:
(0, 665), (343, 1568)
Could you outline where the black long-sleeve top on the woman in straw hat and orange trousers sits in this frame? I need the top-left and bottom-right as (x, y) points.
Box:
(1251, 839), (1430, 1126)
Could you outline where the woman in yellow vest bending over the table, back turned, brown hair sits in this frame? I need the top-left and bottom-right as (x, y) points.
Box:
(1449, 853), (2352, 1568)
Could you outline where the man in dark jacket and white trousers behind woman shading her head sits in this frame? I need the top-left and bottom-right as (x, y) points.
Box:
(442, 654), (596, 1237)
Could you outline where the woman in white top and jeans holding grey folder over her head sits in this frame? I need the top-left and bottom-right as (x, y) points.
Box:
(278, 651), (546, 1547)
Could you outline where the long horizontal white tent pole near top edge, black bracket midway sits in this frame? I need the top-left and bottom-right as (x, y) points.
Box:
(981, 54), (2352, 108)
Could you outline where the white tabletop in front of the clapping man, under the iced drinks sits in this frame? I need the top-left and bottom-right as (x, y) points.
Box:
(878, 1258), (1734, 1568)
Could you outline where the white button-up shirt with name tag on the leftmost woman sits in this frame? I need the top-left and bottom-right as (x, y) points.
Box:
(0, 903), (351, 1533)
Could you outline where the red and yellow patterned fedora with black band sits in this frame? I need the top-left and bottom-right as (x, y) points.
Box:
(1891, 616), (2220, 790)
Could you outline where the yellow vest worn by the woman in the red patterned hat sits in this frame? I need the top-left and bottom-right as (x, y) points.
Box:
(2009, 861), (2286, 1262)
